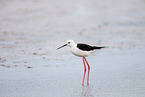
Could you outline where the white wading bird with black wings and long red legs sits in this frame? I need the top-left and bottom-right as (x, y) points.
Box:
(57, 40), (105, 86)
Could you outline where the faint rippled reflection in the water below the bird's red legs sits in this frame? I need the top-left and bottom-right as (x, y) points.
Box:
(81, 86), (94, 97)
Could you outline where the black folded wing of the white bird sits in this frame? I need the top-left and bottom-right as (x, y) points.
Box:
(77, 43), (105, 51)
